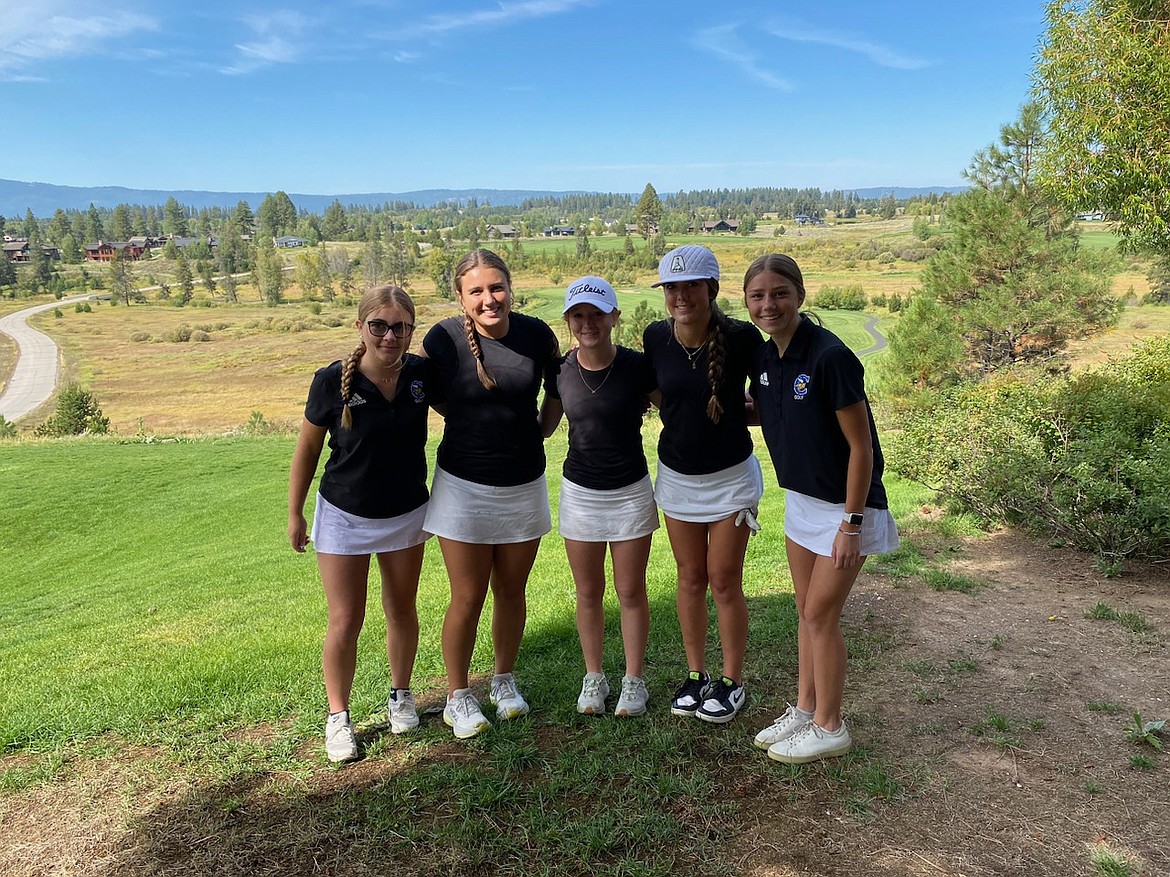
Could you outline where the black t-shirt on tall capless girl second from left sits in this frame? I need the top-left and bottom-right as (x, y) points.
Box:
(422, 312), (558, 486)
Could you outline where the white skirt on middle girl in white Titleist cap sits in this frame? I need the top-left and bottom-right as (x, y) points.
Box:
(558, 474), (659, 543)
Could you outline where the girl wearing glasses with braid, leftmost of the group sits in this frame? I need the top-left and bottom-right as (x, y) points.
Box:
(288, 286), (431, 761)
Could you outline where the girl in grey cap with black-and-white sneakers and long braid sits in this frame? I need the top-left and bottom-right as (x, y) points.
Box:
(642, 244), (764, 723)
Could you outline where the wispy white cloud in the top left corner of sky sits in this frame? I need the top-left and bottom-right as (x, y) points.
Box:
(0, 0), (158, 81)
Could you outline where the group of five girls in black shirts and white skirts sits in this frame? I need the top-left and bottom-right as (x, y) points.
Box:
(289, 244), (897, 762)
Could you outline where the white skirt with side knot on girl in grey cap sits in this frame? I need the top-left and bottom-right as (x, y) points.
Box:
(654, 454), (764, 524)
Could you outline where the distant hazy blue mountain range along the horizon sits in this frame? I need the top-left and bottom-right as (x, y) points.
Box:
(0, 180), (966, 219)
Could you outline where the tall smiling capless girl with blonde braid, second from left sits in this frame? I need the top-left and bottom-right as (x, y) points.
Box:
(422, 249), (559, 739)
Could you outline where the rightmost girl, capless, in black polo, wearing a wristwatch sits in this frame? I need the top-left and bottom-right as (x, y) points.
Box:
(743, 253), (899, 764)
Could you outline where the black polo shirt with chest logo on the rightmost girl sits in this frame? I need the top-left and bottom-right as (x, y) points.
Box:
(751, 317), (887, 509)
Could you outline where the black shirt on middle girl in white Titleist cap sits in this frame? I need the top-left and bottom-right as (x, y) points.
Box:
(549, 347), (654, 490)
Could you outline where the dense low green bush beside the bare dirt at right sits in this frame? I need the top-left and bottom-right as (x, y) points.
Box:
(887, 336), (1170, 571)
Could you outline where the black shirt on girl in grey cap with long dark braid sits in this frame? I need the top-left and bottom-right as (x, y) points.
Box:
(642, 317), (764, 475)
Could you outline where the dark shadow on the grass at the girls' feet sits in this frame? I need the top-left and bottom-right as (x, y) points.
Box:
(108, 579), (907, 877)
